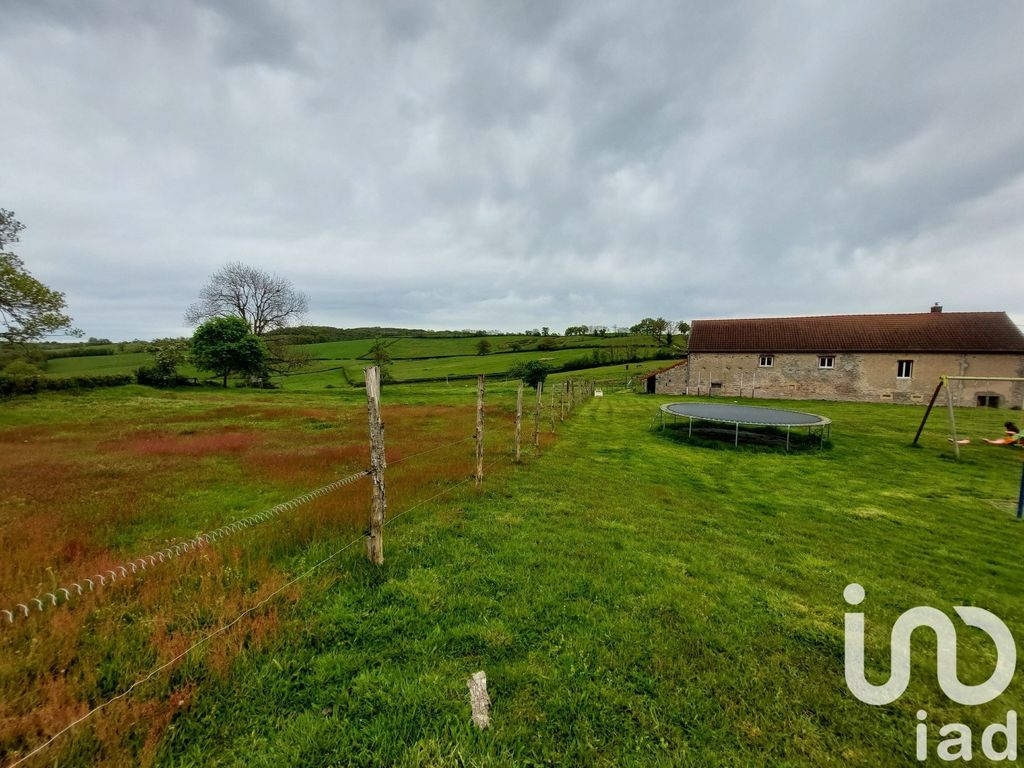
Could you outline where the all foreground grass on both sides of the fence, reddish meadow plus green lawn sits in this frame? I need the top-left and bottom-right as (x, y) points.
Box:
(0, 382), (1024, 766)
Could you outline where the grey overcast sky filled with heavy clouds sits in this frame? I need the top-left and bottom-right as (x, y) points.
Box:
(0, 0), (1024, 339)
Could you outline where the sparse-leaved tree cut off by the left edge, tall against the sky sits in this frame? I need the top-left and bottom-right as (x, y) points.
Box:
(0, 208), (82, 343)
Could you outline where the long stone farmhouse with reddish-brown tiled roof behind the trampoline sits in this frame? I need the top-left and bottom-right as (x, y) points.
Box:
(645, 304), (1024, 408)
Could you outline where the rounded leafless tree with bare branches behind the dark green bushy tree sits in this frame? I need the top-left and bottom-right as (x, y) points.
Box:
(185, 261), (309, 336)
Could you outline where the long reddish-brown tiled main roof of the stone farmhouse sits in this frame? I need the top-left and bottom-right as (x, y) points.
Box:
(689, 312), (1024, 354)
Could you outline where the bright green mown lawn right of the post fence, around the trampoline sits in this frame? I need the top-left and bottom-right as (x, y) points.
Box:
(125, 388), (1024, 766)
